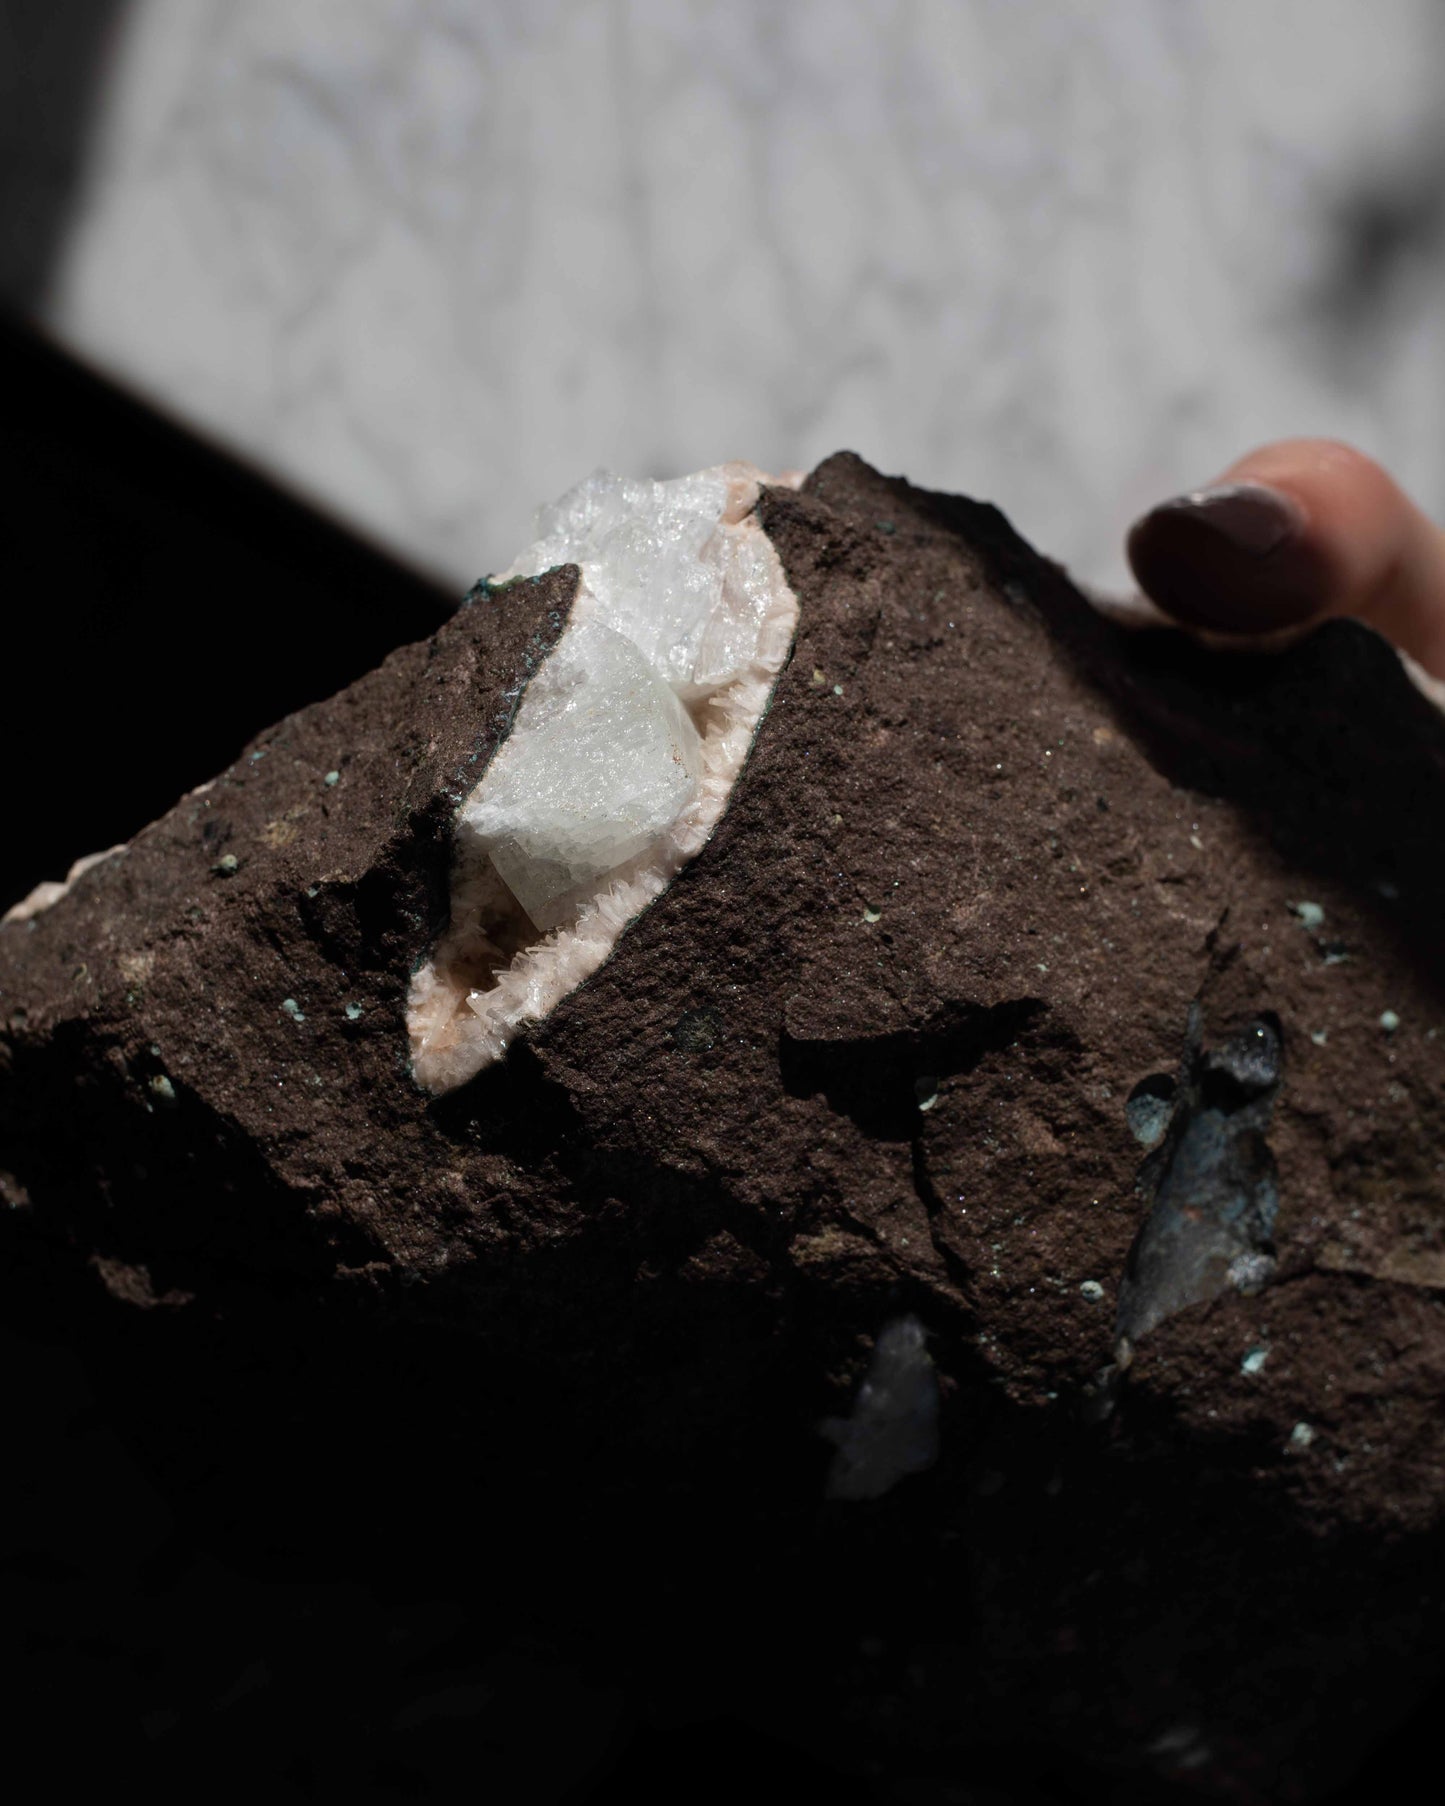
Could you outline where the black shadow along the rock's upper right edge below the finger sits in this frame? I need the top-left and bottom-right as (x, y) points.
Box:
(903, 469), (1445, 995)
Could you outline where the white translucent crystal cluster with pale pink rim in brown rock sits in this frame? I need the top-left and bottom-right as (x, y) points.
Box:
(406, 464), (798, 1091)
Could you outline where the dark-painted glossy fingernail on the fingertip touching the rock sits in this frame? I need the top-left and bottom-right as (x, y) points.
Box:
(1129, 482), (1324, 632)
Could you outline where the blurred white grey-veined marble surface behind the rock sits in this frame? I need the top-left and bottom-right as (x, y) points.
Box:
(11, 0), (1445, 589)
